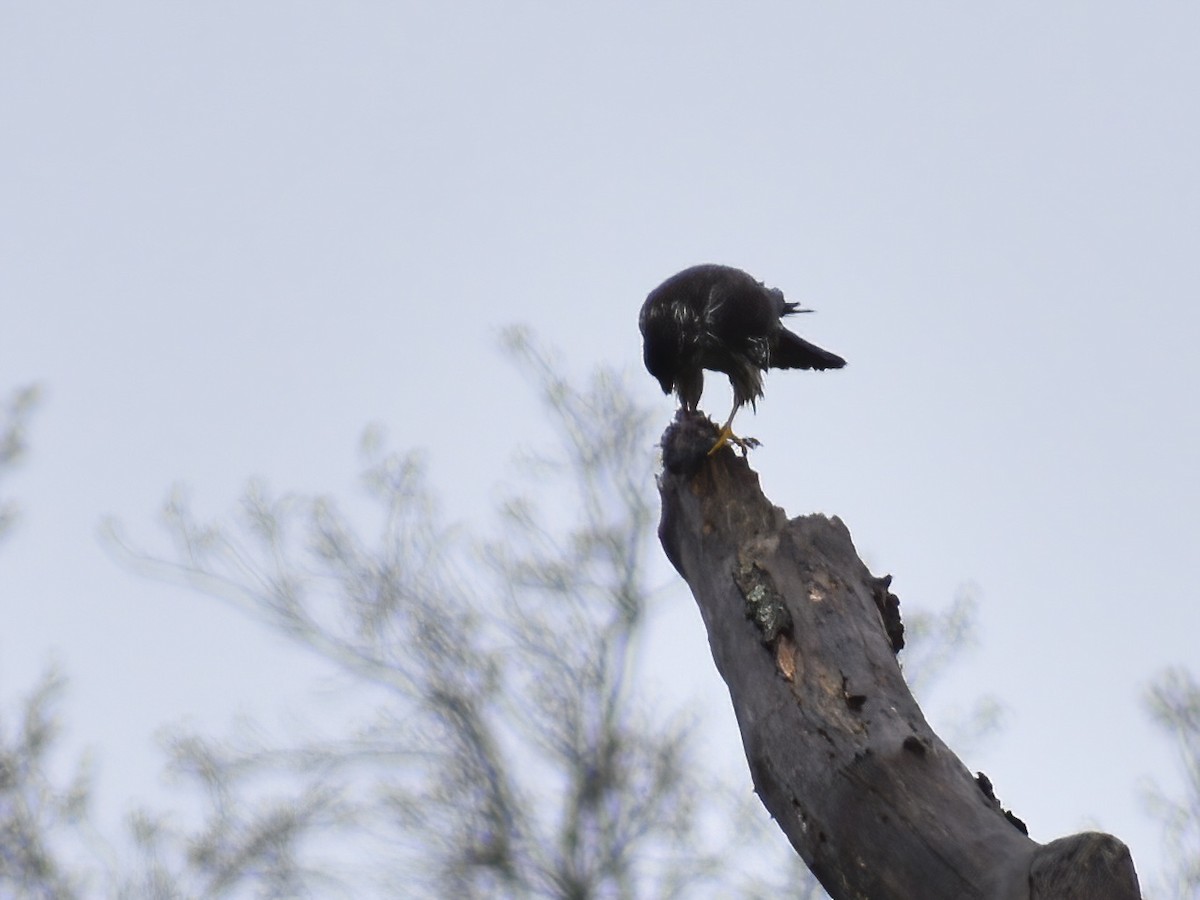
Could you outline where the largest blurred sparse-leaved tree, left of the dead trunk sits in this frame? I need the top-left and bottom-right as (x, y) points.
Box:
(103, 331), (806, 898)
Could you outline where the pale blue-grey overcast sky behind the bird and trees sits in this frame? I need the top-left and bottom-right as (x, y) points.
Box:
(0, 0), (1200, 880)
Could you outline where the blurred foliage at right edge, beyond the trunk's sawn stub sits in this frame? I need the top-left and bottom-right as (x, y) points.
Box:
(1145, 667), (1200, 900)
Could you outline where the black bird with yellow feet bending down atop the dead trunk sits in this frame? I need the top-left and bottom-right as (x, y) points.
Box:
(638, 265), (846, 454)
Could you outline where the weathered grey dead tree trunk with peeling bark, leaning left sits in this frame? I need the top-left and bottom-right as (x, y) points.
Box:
(659, 414), (1139, 900)
